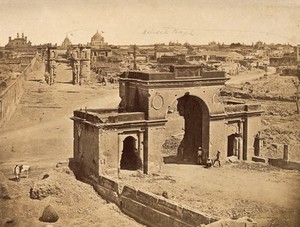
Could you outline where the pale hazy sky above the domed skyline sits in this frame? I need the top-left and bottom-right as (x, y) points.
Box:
(0, 0), (300, 46)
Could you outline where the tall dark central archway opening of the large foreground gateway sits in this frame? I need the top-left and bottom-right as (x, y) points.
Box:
(177, 95), (209, 164)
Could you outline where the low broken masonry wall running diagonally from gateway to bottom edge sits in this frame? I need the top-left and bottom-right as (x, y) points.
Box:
(69, 159), (257, 227)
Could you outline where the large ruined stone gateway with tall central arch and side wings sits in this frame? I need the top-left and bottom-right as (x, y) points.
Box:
(72, 65), (262, 175)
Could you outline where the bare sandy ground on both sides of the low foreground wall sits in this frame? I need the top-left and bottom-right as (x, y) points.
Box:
(0, 61), (300, 227)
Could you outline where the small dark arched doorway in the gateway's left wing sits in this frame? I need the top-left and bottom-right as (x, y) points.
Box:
(120, 136), (142, 170)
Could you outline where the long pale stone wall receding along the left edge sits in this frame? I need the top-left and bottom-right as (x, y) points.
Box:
(0, 56), (37, 127)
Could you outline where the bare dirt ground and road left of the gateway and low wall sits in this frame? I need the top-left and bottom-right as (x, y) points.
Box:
(0, 59), (141, 227)
